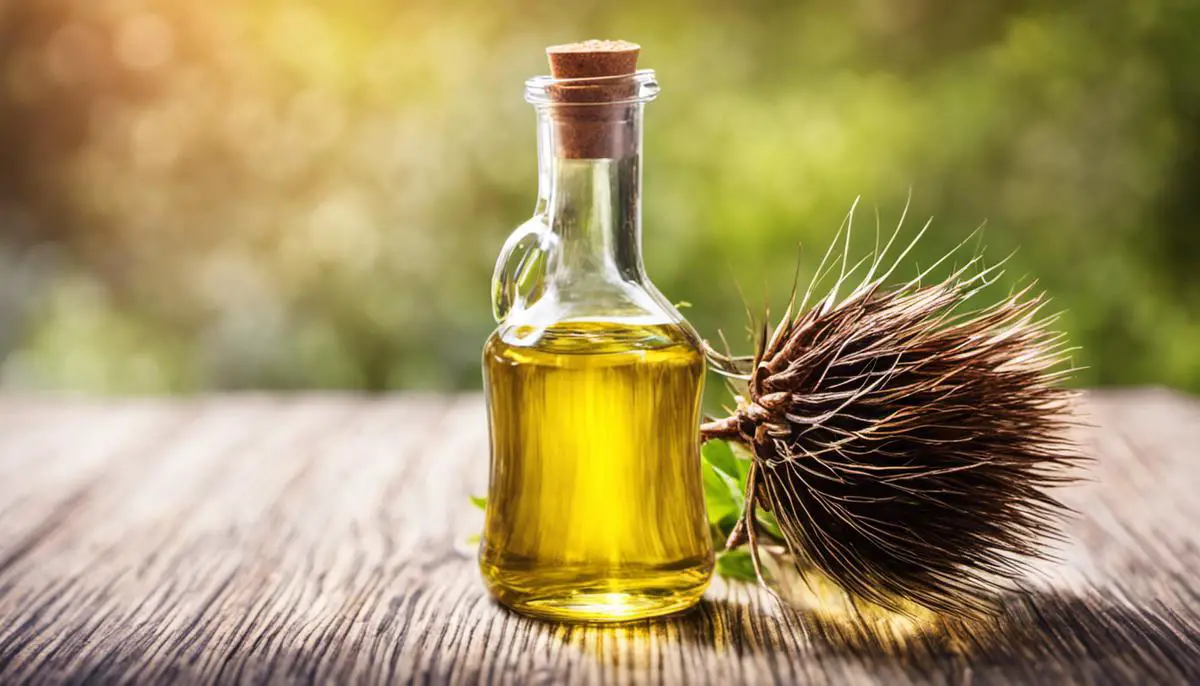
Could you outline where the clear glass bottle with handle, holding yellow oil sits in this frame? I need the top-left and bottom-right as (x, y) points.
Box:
(480, 58), (713, 622)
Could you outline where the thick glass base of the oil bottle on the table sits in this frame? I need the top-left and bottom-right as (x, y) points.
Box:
(482, 565), (710, 624)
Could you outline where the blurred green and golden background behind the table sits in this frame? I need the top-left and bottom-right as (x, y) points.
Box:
(0, 0), (1200, 393)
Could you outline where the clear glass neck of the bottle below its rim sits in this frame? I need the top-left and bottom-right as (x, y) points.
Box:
(536, 103), (646, 283)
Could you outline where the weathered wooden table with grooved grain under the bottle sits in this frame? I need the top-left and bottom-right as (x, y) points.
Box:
(0, 390), (1200, 684)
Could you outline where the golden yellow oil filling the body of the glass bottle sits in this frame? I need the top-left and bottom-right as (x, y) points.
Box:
(480, 321), (713, 622)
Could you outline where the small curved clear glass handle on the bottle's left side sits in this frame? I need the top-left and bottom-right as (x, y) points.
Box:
(492, 215), (554, 323)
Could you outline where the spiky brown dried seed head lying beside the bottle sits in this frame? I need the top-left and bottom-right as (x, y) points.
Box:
(702, 207), (1080, 615)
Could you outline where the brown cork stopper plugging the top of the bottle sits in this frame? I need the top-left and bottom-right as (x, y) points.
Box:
(546, 40), (641, 160)
